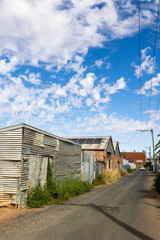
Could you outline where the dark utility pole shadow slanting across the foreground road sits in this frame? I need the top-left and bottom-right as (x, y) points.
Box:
(61, 203), (154, 240)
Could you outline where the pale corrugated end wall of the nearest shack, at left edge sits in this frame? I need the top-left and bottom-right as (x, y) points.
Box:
(0, 128), (22, 203)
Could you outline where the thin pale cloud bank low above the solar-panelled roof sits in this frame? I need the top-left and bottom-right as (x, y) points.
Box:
(66, 112), (150, 136)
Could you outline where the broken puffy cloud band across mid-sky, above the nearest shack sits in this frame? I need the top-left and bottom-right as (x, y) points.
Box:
(0, 71), (126, 122)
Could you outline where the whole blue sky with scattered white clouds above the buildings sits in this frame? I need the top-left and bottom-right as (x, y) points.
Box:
(0, 0), (160, 156)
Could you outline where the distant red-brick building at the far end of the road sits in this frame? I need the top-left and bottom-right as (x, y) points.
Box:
(122, 152), (146, 167)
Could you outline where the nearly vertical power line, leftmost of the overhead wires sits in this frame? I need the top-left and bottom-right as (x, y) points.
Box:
(138, 0), (142, 129)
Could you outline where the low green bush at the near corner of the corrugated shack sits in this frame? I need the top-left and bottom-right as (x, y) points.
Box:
(27, 186), (53, 208)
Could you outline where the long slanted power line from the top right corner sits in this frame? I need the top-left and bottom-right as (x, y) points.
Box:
(147, 0), (160, 125)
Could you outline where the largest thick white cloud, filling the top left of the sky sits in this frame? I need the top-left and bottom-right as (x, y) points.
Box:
(0, 0), (155, 72)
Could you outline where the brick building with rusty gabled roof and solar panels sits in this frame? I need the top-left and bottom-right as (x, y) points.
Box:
(68, 136), (121, 170)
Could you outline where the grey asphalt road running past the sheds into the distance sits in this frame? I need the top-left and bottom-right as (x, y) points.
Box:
(0, 171), (160, 240)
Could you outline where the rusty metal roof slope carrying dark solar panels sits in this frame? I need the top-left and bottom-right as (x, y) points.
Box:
(67, 136), (112, 150)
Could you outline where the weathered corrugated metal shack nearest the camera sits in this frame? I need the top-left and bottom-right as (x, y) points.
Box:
(0, 123), (81, 207)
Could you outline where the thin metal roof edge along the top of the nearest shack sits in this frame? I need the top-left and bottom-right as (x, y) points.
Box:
(0, 123), (80, 146)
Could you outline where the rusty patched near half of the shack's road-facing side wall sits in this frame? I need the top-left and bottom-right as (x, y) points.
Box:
(21, 127), (58, 202)
